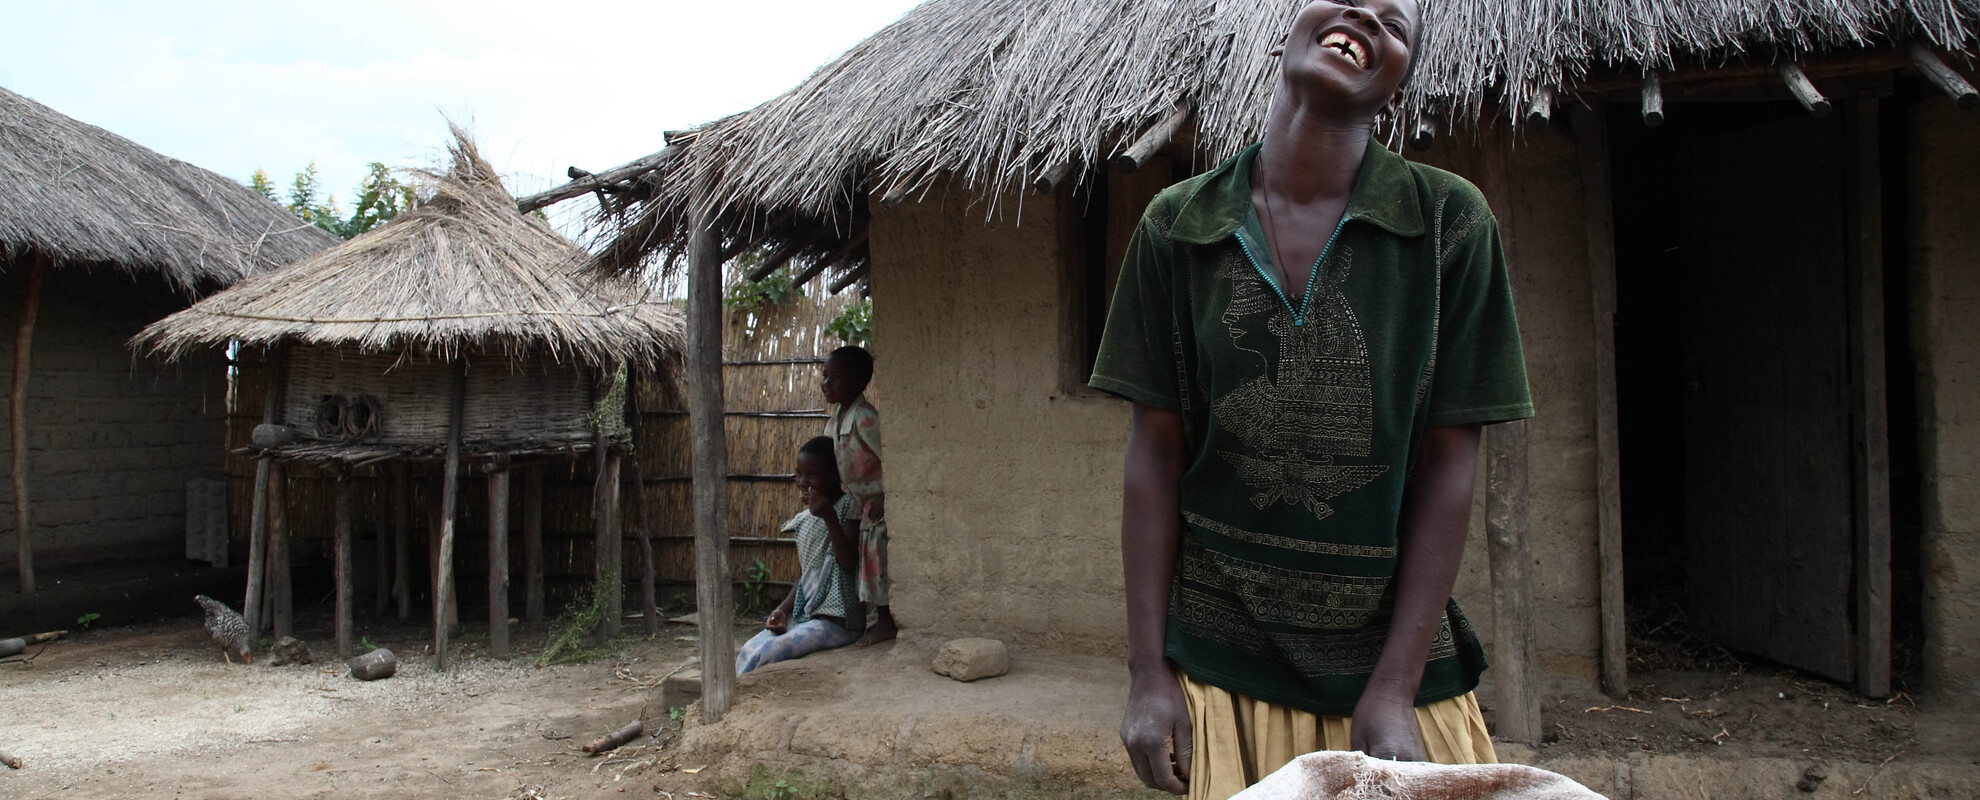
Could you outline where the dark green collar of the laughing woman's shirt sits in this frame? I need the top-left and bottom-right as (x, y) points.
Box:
(1168, 139), (1424, 244)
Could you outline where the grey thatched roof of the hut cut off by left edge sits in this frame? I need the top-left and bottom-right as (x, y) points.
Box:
(0, 89), (337, 293)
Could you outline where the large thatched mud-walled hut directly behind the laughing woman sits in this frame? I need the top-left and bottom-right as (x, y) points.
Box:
(523, 0), (1980, 724)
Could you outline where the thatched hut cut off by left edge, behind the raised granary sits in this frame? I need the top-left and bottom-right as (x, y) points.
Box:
(0, 89), (337, 592)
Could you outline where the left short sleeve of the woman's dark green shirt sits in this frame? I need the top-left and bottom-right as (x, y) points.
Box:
(1087, 205), (1182, 412)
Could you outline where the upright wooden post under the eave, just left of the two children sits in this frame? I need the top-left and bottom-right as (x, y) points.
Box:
(687, 214), (737, 723)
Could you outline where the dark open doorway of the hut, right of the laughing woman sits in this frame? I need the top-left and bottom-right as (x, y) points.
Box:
(1610, 103), (1903, 681)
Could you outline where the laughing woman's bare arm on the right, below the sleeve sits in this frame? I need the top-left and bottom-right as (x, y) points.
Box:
(1350, 426), (1479, 760)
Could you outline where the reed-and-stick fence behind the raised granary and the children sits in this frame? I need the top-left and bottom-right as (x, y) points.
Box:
(226, 283), (855, 610)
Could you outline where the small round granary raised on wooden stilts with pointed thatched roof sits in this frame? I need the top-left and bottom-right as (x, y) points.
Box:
(133, 129), (681, 663)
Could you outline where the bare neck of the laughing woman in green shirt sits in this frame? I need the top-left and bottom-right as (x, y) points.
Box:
(1253, 83), (1374, 204)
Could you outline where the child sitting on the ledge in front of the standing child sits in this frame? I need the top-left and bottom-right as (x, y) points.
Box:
(737, 436), (865, 675)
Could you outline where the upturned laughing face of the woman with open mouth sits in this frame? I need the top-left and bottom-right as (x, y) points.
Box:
(1281, 0), (1422, 113)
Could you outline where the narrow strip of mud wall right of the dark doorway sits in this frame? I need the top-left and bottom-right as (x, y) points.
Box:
(1891, 97), (1980, 707)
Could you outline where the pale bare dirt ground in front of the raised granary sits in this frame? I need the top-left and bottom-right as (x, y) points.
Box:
(0, 600), (748, 800)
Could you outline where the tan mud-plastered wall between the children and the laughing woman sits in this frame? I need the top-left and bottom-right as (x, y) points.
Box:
(871, 183), (1129, 653)
